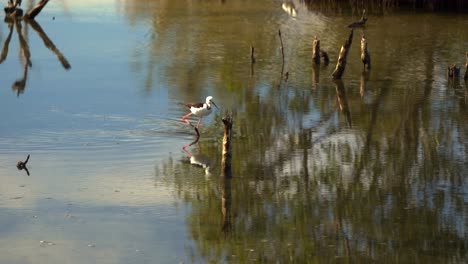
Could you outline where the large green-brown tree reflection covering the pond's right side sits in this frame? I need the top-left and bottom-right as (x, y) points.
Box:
(126, 1), (468, 263)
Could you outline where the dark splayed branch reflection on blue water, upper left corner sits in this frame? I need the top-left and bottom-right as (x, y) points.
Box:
(0, 16), (71, 96)
